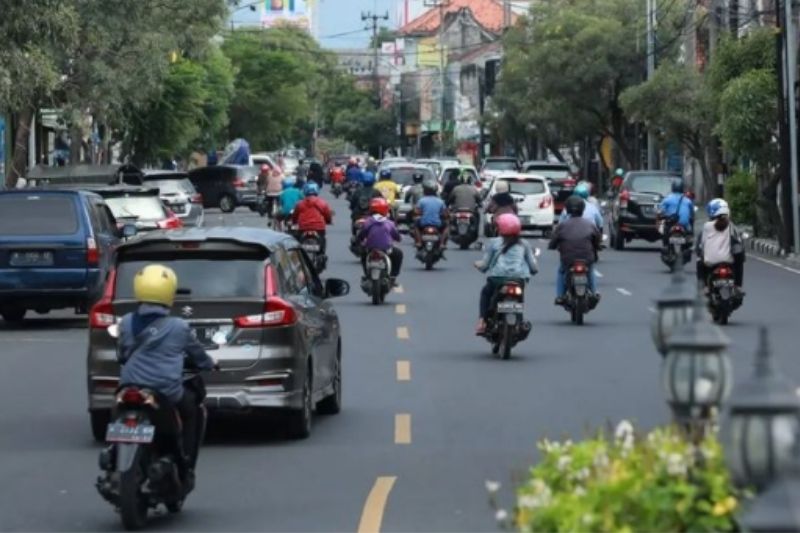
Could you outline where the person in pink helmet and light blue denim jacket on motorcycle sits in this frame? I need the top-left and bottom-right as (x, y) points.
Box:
(475, 213), (539, 335)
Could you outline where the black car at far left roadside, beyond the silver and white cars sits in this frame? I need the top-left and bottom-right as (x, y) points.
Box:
(189, 165), (260, 213)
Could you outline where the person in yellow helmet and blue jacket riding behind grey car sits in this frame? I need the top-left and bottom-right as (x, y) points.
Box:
(117, 264), (216, 480)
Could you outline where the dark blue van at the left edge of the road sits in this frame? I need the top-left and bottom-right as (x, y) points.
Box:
(0, 189), (121, 322)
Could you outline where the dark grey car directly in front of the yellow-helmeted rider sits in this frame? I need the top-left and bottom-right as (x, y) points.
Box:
(87, 227), (350, 440)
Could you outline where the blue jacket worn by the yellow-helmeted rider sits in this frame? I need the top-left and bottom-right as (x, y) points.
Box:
(117, 304), (214, 403)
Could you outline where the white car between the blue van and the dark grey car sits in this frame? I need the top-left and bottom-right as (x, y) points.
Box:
(92, 187), (183, 232)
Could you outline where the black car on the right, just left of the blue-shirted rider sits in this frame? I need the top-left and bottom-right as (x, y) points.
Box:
(609, 170), (682, 250)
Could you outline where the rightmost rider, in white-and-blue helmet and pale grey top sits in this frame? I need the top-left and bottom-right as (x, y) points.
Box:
(696, 198), (745, 298)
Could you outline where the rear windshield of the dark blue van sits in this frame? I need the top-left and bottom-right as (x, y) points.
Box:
(0, 194), (78, 235)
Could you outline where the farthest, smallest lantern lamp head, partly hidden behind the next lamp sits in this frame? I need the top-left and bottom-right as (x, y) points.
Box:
(650, 257), (694, 357)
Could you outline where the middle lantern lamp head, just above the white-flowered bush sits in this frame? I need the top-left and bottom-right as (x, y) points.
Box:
(661, 291), (732, 437)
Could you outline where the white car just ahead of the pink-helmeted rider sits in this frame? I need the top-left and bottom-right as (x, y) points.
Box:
(485, 173), (555, 238)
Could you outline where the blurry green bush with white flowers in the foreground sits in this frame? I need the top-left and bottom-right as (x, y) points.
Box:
(500, 421), (738, 531)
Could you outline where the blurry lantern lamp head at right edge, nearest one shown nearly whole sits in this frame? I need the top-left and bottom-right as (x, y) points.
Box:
(726, 327), (800, 490)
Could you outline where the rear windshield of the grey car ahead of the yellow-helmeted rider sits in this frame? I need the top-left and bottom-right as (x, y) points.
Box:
(115, 254), (264, 300)
